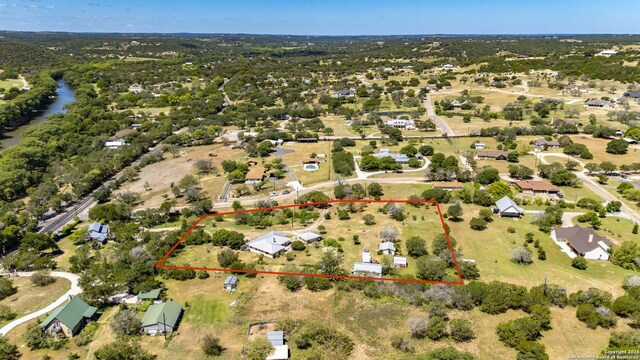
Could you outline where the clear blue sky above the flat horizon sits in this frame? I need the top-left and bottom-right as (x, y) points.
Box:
(0, 0), (640, 35)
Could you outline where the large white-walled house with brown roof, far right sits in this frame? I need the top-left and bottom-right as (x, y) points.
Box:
(551, 226), (611, 260)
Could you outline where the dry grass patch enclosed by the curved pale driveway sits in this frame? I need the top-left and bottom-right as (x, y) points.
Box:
(0, 277), (71, 326)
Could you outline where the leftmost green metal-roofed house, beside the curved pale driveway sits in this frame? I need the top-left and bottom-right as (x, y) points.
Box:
(40, 296), (98, 337)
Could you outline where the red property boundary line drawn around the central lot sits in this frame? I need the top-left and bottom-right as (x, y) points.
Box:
(155, 200), (464, 285)
